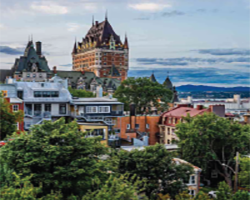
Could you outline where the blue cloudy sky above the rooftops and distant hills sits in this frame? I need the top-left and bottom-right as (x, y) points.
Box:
(0, 0), (250, 86)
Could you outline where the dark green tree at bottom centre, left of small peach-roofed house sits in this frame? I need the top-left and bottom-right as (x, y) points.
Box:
(115, 144), (193, 198)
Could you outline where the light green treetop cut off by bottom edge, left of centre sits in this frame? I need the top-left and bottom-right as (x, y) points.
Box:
(82, 175), (147, 200)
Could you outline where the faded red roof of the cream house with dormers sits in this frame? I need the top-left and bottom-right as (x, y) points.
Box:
(162, 107), (209, 117)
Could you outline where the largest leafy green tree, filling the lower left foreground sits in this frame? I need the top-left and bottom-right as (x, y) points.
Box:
(0, 118), (109, 198)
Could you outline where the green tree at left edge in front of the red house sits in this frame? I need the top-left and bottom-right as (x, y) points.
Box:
(0, 94), (23, 140)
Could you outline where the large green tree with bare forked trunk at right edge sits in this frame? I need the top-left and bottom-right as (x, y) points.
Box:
(176, 113), (250, 187)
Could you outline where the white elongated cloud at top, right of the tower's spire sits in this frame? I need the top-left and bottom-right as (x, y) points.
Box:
(129, 3), (172, 11)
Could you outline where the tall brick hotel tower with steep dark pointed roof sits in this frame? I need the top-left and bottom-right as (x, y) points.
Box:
(72, 15), (129, 81)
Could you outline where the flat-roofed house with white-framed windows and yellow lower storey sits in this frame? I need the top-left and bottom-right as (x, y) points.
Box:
(71, 89), (124, 143)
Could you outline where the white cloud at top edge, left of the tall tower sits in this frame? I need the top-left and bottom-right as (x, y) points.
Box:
(30, 2), (69, 15)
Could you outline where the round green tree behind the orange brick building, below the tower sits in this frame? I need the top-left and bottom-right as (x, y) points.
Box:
(114, 77), (172, 113)
